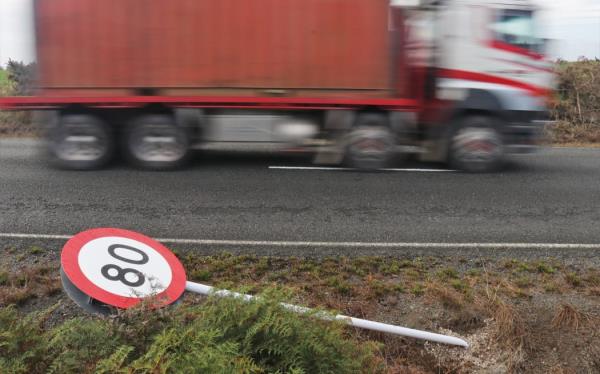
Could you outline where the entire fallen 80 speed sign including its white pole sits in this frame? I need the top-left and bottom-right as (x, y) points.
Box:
(61, 228), (469, 347)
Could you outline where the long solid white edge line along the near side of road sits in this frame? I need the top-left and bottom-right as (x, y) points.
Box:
(0, 233), (600, 249)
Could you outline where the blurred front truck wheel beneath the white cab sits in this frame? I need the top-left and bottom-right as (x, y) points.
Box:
(449, 116), (504, 173)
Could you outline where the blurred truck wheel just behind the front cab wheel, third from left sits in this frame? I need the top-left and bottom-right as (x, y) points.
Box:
(345, 114), (394, 170)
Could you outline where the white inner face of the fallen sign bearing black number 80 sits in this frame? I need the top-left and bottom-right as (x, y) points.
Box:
(77, 236), (173, 298)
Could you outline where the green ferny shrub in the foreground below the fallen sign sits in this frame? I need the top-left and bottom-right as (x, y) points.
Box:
(0, 290), (383, 373)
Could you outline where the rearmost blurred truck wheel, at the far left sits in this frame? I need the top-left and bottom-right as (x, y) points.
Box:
(48, 114), (115, 170)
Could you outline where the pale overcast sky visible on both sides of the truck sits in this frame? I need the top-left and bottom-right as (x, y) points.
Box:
(0, 0), (600, 65)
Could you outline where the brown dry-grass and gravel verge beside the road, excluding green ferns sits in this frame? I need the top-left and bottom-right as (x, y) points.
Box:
(0, 247), (600, 373)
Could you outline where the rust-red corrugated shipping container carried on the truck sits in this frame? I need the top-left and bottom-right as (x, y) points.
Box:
(36, 0), (394, 97)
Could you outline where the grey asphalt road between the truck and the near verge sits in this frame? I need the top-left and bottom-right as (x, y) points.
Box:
(0, 139), (600, 254)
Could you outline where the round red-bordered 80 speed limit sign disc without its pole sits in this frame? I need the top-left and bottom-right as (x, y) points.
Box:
(61, 228), (186, 308)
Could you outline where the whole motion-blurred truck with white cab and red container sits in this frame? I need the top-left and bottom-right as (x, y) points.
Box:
(0, 0), (553, 172)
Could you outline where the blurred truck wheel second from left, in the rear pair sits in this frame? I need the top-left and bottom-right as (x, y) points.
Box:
(125, 114), (190, 171)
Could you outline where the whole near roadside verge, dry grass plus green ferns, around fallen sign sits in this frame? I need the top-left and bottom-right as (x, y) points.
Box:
(0, 247), (600, 373)
